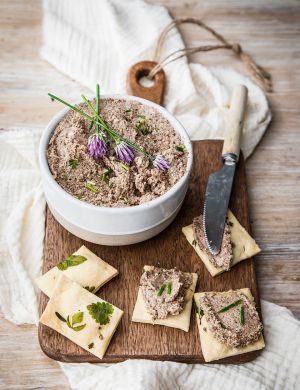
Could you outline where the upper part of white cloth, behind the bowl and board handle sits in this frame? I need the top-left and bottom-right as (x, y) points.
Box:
(41, 0), (271, 157)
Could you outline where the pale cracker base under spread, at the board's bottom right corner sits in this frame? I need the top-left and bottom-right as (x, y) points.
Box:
(194, 288), (265, 362)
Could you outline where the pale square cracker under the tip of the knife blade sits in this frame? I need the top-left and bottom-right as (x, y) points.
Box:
(182, 210), (260, 276)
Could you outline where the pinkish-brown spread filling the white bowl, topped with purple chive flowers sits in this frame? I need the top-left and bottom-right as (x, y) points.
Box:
(47, 98), (188, 207)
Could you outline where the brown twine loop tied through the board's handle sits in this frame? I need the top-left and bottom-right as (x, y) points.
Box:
(148, 18), (272, 92)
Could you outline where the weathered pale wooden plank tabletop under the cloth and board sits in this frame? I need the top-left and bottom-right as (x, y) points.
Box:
(0, 0), (300, 389)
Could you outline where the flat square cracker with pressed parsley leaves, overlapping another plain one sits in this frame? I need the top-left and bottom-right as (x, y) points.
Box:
(40, 275), (123, 359)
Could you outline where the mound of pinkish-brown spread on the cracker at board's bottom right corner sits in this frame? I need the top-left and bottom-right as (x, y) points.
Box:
(199, 291), (262, 347)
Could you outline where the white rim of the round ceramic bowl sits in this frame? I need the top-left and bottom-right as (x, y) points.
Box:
(39, 94), (193, 214)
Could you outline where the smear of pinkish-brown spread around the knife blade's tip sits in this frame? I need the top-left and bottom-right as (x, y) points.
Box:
(193, 215), (232, 271)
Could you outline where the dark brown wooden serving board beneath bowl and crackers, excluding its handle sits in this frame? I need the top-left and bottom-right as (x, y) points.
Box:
(39, 141), (260, 363)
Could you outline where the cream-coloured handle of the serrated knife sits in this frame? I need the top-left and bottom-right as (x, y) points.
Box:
(222, 85), (248, 161)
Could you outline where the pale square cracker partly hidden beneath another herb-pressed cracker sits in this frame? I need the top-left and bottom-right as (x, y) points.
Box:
(36, 245), (118, 297)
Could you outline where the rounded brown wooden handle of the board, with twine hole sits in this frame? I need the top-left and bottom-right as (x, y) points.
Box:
(127, 61), (166, 105)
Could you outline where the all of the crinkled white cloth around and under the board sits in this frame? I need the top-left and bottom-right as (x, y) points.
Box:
(0, 0), (300, 390)
